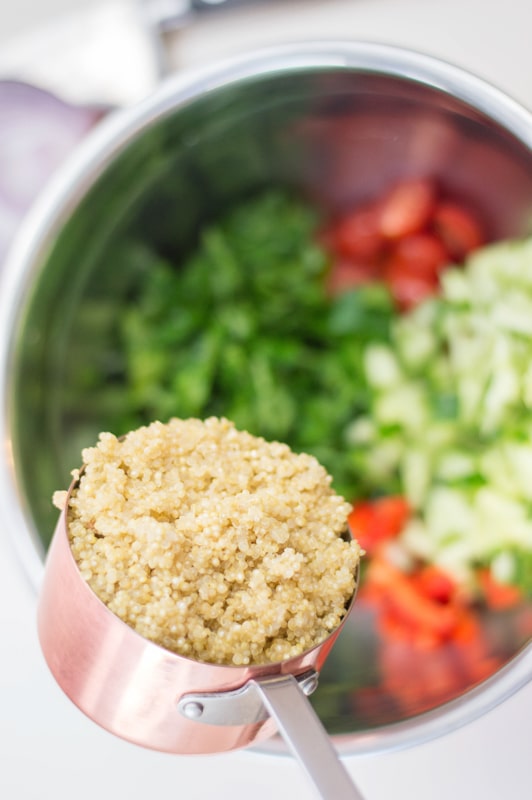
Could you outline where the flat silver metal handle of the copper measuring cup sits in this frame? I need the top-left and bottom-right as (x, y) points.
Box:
(253, 675), (364, 800)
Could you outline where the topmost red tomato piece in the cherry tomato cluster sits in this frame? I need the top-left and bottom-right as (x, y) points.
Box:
(379, 178), (436, 239)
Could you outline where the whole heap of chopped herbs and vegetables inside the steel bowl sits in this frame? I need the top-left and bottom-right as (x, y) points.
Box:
(74, 178), (532, 717)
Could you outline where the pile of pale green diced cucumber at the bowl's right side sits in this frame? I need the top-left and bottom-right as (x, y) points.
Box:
(351, 234), (532, 594)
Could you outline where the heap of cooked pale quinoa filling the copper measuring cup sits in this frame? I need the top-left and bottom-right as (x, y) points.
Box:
(54, 417), (360, 665)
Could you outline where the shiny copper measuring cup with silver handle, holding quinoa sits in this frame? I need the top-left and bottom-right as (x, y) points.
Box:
(38, 482), (362, 800)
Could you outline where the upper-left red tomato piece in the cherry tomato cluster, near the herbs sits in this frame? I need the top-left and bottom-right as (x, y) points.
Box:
(328, 204), (383, 260)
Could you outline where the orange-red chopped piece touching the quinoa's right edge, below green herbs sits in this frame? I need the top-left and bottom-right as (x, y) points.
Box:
(348, 496), (410, 554)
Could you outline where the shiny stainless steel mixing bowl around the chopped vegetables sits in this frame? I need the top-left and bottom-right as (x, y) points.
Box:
(0, 42), (532, 753)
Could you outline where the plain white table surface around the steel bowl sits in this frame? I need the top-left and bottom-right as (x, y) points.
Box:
(0, 0), (532, 800)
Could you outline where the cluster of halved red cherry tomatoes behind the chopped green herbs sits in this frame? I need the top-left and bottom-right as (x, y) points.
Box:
(319, 178), (484, 311)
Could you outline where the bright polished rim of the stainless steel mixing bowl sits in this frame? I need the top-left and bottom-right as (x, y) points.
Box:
(0, 40), (532, 755)
